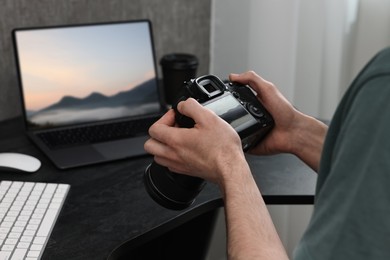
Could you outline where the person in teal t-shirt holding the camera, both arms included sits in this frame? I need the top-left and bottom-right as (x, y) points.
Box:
(145, 47), (390, 259)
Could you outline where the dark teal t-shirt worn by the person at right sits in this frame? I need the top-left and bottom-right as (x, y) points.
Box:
(294, 49), (390, 260)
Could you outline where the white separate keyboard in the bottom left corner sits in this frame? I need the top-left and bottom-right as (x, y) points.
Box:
(0, 181), (70, 260)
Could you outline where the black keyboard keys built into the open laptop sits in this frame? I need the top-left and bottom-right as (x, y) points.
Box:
(38, 117), (157, 149)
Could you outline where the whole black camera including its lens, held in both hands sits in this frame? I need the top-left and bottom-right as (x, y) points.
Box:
(144, 75), (274, 210)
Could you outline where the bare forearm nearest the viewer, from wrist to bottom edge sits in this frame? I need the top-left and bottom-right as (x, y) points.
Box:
(220, 157), (288, 260)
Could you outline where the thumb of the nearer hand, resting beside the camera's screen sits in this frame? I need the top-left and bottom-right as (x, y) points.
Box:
(177, 98), (214, 124)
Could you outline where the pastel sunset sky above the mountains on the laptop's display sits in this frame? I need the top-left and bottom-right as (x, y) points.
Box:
(16, 23), (155, 111)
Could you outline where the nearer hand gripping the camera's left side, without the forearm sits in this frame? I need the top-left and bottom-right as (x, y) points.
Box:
(145, 98), (244, 183)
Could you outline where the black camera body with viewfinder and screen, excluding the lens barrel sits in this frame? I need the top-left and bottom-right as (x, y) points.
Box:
(173, 75), (274, 151)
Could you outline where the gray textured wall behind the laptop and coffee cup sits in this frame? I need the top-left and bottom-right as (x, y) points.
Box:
(0, 0), (211, 120)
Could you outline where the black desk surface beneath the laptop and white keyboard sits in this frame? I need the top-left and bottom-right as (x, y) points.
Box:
(0, 118), (317, 260)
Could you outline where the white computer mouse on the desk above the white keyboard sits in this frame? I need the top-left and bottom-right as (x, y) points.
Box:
(0, 153), (41, 172)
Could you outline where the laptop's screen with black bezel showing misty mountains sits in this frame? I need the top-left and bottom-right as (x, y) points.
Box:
(13, 21), (161, 129)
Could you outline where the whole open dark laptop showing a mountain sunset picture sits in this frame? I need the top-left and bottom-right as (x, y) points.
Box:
(12, 20), (166, 169)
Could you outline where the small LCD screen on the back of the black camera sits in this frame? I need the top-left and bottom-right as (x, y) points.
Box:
(204, 94), (257, 133)
